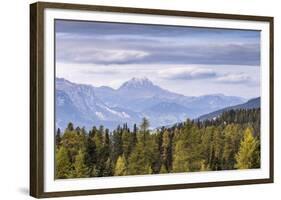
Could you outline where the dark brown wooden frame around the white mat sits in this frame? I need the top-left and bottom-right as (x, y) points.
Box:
(30, 2), (274, 198)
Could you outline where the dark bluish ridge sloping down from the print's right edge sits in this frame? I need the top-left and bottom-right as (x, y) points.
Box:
(198, 97), (260, 121)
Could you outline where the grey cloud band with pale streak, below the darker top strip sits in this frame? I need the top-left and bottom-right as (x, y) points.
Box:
(56, 36), (260, 65)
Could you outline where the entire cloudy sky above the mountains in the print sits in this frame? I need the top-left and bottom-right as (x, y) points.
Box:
(56, 20), (260, 98)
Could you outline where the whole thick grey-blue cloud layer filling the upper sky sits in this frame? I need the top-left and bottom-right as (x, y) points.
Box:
(56, 21), (260, 66)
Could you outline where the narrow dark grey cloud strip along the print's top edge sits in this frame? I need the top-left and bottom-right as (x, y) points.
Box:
(56, 20), (259, 38)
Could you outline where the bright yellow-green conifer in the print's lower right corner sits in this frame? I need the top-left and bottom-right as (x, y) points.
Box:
(235, 128), (259, 169)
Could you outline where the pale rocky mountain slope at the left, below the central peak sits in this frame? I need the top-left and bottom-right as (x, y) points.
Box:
(56, 79), (141, 128)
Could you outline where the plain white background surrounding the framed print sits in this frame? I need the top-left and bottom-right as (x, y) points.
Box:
(0, 0), (281, 200)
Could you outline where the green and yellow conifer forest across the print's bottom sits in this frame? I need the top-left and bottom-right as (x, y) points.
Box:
(55, 109), (260, 179)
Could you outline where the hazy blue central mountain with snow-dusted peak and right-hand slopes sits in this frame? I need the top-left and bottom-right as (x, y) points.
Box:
(95, 78), (245, 118)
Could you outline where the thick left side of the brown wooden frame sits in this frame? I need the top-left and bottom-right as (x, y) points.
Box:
(30, 3), (44, 198)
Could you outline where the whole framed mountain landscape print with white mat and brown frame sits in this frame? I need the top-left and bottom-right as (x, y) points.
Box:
(30, 2), (273, 198)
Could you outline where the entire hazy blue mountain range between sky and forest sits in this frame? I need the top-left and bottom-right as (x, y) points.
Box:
(56, 78), (249, 129)
